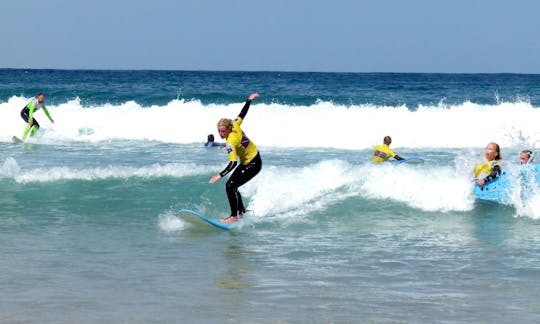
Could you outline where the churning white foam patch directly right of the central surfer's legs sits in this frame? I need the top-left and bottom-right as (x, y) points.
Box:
(242, 160), (474, 220)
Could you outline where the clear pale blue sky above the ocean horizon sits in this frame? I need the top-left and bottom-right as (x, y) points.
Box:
(0, 0), (540, 73)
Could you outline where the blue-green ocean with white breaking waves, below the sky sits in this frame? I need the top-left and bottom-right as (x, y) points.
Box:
(0, 69), (540, 323)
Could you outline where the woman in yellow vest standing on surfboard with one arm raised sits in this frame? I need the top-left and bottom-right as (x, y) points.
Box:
(208, 93), (262, 223)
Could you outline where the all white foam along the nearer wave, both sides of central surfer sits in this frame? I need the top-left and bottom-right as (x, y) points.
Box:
(0, 153), (540, 219)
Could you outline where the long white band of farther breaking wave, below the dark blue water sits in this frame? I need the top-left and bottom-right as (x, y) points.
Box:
(0, 97), (540, 149)
